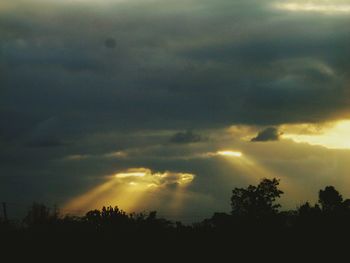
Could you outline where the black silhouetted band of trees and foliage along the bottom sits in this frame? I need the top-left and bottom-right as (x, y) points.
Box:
(0, 179), (350, 262)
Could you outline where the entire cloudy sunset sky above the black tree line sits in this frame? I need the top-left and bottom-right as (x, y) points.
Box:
(0, 0), (350, 222)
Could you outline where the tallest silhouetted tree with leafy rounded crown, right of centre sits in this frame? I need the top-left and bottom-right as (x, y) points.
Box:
(231, 178), (283, 218)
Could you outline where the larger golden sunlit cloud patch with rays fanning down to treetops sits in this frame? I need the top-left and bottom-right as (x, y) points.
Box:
(63, 168), (195, 213)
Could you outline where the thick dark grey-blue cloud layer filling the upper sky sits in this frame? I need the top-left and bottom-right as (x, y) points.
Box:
(0, 0), (350, 140)
